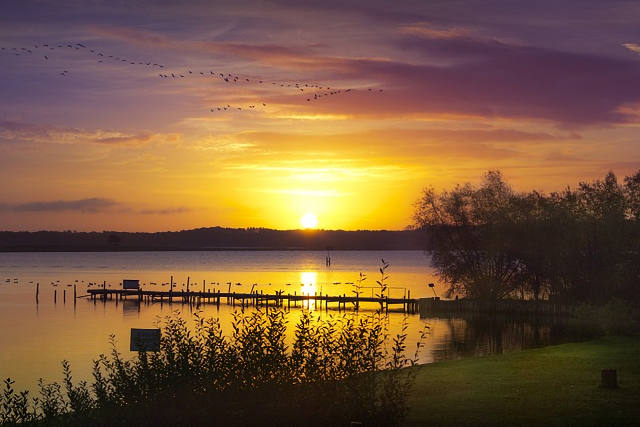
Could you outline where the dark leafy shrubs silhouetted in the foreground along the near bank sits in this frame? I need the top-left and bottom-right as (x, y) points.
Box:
(0, 310), (426, 426)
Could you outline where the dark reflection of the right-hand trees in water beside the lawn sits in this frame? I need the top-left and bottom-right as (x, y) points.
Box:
(434, 315), (575, 360)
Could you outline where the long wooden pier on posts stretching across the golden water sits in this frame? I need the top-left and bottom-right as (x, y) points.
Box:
(87, 286), (417, 313)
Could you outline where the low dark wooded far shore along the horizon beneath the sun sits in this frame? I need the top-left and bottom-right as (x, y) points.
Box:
(0, 227), (424, 252)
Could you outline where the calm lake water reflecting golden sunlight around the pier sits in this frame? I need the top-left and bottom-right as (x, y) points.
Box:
(0, 251), (584, 389)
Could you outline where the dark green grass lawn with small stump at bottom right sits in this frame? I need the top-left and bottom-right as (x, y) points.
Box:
(407, 337), (640, 427)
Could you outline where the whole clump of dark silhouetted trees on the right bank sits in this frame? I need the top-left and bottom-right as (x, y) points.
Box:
(415, 171), (640, 306)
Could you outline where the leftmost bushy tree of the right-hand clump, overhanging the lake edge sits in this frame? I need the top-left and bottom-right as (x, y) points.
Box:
(415, 171), (525, 300)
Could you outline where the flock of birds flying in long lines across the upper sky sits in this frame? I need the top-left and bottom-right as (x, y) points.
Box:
(0, 43), (384, 113)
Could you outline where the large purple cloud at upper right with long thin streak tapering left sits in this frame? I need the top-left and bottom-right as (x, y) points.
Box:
(96, 24), (640, 126)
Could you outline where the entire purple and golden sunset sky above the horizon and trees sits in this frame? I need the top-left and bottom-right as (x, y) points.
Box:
(0, 0), (640, 231)
